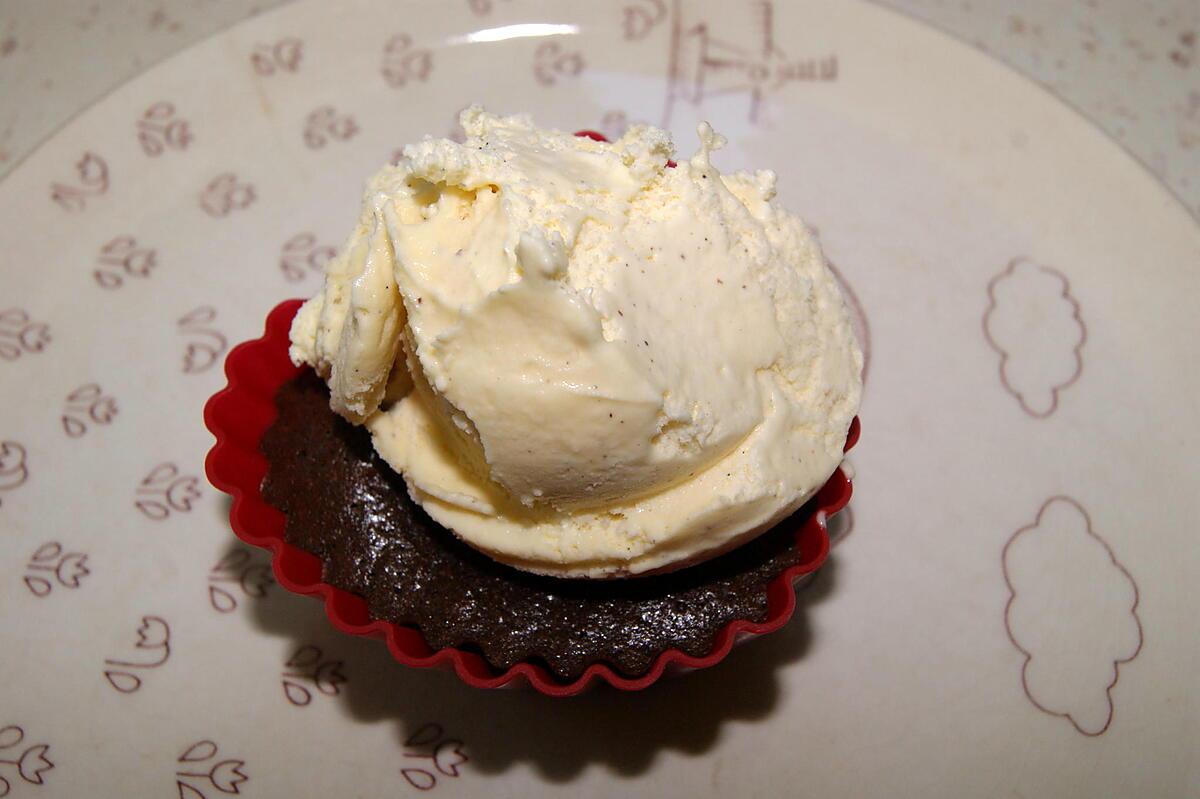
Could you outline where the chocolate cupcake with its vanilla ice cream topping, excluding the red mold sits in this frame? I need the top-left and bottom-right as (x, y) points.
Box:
(208, 107), (863, 680)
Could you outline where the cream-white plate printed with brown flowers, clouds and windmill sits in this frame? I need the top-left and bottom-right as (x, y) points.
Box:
(0, 0), (1200, 799)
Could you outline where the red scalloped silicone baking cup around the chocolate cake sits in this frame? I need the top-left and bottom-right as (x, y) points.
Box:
(204, 300), (859, 696)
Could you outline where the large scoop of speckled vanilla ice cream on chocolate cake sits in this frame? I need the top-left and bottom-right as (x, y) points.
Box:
(292, 108), (863, 577)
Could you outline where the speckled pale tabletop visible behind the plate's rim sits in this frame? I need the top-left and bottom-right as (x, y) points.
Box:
(0, 0), (1200, 216)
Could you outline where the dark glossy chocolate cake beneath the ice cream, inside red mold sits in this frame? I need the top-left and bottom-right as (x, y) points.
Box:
(260, 372), (812, 679)
